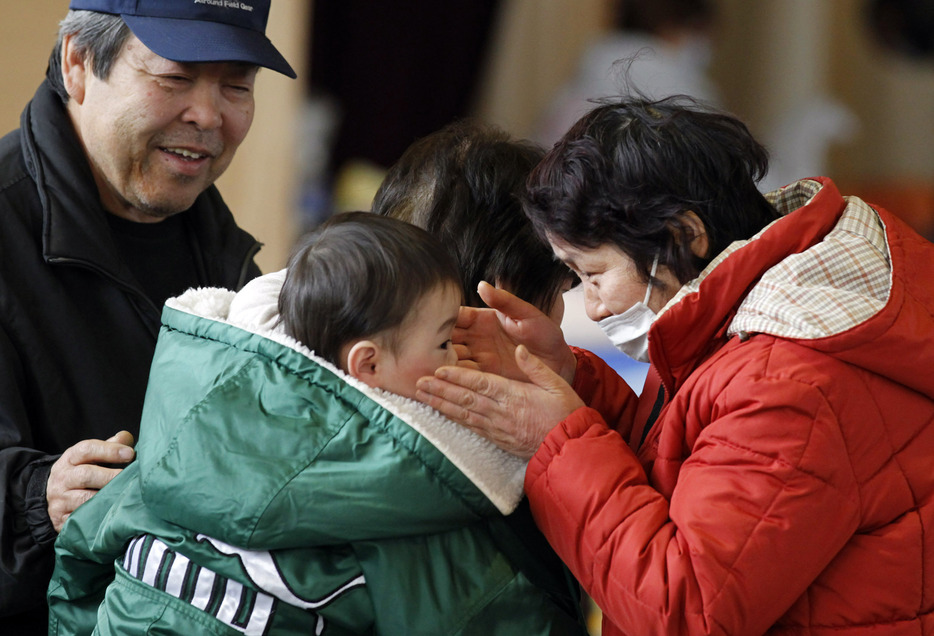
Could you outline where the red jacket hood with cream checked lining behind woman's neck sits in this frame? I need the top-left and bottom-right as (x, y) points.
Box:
(650, 178), (934, 396)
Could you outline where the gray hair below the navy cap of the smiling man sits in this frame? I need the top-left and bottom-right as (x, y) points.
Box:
(46, 11), (131, 102)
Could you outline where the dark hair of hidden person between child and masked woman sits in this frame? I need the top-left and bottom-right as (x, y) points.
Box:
(372, 120), (574, 312)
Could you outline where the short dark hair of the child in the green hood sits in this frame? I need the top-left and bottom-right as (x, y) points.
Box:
(279, 212), (460, 366)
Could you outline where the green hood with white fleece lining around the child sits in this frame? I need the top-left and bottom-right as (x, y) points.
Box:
(139, 272), (526, 549)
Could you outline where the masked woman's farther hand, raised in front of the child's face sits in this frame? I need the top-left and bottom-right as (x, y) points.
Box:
(454, 283), (577, 384)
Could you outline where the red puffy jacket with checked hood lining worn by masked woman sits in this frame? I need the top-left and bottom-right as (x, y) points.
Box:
(526, 179), (934, 636)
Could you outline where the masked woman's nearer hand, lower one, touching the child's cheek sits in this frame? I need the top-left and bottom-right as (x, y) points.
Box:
(415, 345), (584, 458)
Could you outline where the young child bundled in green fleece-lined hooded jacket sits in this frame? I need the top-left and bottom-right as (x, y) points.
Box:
(49, 212), (585, 636)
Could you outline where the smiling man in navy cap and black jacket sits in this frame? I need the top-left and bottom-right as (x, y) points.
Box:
(0, 0), (295, 635)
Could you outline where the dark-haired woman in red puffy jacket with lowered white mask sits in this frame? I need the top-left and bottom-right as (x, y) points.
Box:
(416, 98), (934, 636)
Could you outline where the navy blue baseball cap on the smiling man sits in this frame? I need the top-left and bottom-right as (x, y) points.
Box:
(69, 0), (295, 78)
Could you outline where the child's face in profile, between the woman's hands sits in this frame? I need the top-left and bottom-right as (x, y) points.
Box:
(361, 283), (461, 399)
